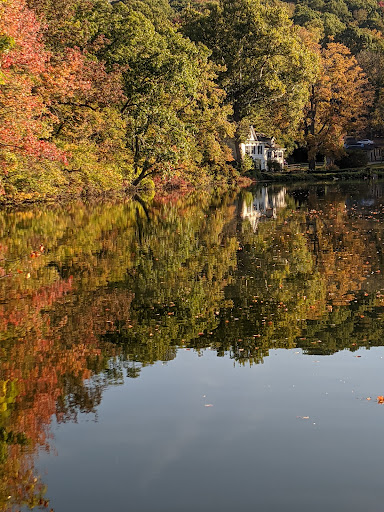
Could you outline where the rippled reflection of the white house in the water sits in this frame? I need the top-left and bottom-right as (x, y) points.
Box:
(241, 187), (286, 231)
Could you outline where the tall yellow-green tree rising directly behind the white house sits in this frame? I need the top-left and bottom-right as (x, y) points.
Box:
(184, 0), (316, 159)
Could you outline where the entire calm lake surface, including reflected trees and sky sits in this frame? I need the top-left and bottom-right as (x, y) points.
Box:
(0, 182), (384, 512)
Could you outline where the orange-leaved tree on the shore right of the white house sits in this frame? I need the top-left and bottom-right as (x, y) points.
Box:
(303, 43), (371, 170)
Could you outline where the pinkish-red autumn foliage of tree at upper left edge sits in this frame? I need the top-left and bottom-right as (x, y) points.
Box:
(0, 0), (65, 193)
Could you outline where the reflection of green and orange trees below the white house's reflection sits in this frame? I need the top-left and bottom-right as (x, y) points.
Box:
(190, 186), (384, 363)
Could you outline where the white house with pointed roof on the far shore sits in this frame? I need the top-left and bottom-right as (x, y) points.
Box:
(240, 126), (285, 171)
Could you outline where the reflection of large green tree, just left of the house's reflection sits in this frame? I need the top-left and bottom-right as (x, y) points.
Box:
(100, 193), (237, 365)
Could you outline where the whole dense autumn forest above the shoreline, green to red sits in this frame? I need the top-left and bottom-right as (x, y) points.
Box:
(0, 0), (384, 198)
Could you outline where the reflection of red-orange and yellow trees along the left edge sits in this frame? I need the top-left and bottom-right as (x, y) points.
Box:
(0, 205), (141, 510)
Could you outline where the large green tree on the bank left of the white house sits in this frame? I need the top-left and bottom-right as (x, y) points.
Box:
(98, 2), (230, 185)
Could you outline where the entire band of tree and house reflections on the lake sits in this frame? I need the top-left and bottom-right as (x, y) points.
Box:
(0, 182), (384, 511)
